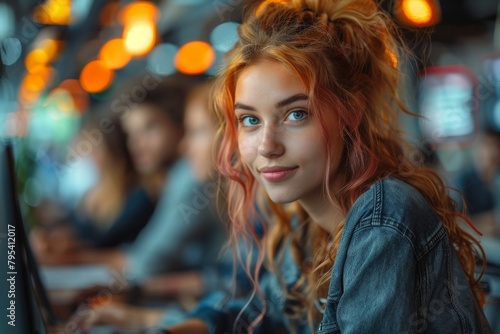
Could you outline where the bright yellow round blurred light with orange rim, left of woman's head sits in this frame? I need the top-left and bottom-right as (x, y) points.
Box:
(123, 21), (156, 56)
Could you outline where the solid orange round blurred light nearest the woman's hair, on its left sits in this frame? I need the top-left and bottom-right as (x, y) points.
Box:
(174, 41), (215, 74)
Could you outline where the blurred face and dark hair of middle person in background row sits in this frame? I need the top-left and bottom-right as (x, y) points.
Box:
(117, 76), (188, 198)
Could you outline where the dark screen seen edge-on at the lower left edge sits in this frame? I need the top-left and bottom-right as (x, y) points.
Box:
(0, 141), (53, 334)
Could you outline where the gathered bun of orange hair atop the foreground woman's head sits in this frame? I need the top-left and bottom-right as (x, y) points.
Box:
(252, 0), (399, 68)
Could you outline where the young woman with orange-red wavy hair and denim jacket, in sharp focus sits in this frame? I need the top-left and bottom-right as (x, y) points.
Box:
(169, 0), (490, 333)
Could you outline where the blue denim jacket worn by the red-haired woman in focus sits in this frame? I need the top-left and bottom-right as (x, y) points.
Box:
(186, 178), (491, 334)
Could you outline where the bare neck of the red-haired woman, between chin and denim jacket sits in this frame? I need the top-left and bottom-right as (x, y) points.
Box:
(299, 196), (345, 234)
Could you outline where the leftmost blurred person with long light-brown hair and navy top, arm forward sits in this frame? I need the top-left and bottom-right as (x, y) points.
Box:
(33, 111), (155, 253)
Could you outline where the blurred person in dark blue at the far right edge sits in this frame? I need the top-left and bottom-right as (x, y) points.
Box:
(454, 129), (500, 237)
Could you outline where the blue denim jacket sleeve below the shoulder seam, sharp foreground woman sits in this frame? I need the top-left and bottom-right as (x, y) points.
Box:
(329, 222), (417, 333)
